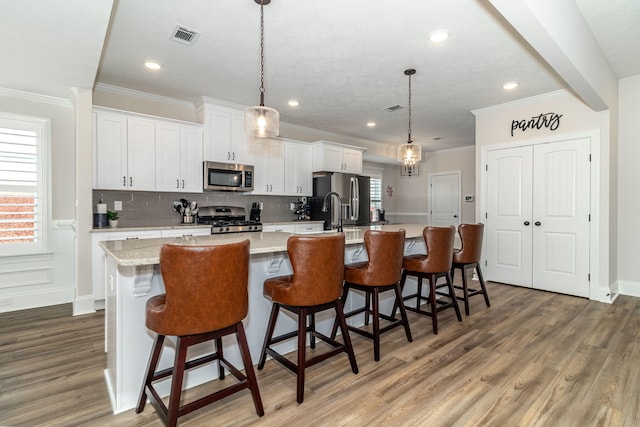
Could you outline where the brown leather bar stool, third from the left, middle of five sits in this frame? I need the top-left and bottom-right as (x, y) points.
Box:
(332, 229), (413, 362)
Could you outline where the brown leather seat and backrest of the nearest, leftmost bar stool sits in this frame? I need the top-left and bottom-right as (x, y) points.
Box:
(146, 240), (249, 336)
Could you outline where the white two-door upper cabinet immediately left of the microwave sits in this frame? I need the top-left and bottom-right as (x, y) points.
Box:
(156, 122), (202, 193)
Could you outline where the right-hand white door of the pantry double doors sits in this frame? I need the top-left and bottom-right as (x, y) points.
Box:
(532, 138), (590, 297)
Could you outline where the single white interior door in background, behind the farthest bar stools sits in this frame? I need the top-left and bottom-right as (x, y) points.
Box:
(429, 172), (461, 227)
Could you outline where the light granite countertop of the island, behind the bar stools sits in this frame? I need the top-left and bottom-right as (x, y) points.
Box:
(100, 224), (425, 266)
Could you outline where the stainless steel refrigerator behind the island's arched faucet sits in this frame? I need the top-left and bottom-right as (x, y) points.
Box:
(310, 172), (371, 230)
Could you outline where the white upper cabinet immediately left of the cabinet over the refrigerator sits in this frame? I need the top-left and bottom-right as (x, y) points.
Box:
(284, 140), (313, 196)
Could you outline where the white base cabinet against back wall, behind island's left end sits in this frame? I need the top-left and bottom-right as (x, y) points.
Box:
(91, 229), (162, 308)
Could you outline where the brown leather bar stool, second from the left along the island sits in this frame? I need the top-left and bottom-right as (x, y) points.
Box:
(258, 233), (358, 403)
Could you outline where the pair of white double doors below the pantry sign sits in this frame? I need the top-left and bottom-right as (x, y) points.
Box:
(485, 138), (590, 297)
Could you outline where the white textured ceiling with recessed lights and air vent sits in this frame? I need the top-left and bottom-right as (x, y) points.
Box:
(0, 0), (640, 158)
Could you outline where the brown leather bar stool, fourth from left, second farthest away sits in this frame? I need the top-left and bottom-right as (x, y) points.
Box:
(393, 226), (462, 334)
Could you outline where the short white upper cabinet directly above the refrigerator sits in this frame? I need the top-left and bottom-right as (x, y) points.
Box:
(312, 141), (365, 175)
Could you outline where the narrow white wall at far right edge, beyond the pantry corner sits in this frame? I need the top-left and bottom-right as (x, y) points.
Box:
(617, 75), (640, 296)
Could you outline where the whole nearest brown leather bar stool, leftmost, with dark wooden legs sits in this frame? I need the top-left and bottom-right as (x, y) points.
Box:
(136, 240), (264, 426)
